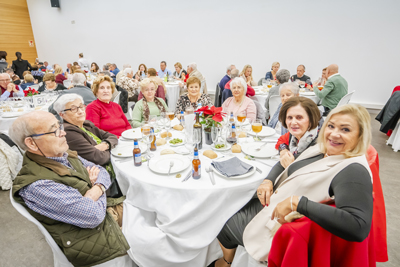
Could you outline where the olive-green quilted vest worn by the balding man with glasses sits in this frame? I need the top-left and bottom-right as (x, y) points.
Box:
(12, 150), (129, 267)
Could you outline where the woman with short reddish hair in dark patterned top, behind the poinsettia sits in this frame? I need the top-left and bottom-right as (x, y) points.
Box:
(175, 77), (213, 114)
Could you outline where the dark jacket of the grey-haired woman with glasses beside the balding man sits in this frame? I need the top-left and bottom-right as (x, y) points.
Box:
(64, 120), (118, 165)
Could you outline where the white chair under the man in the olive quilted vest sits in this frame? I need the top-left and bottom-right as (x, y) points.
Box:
(10, 190), (137, 267)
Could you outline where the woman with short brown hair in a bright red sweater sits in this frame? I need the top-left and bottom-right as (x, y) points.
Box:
(86, 76), (132, 138)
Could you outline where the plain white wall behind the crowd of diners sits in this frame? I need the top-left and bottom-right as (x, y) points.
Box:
(27, 0), (400, 107)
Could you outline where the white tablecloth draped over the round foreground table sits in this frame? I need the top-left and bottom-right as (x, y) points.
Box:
(112, 126), (276, 267)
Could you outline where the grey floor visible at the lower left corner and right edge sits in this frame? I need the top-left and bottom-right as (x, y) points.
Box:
(0, 111), (400, 267)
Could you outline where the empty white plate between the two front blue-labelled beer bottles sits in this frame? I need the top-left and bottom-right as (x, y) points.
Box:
(149, 154), (190, 174)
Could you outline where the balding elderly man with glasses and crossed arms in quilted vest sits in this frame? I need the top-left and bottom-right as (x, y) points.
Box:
(9, 110), (129, 266)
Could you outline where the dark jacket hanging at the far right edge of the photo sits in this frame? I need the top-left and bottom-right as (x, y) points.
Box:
(375, 91), (400, 133)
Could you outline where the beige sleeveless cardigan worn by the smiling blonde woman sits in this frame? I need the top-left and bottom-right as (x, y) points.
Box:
(243, 145), (372, 261)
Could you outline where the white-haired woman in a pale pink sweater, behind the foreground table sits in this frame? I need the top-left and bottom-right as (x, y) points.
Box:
(222, 77), (257, 120)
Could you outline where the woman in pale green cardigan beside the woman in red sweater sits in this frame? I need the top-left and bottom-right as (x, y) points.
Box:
(132, 78), (168, 127)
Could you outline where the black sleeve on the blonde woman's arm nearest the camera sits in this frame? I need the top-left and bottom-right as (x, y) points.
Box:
(297, 163), (373, 242)
